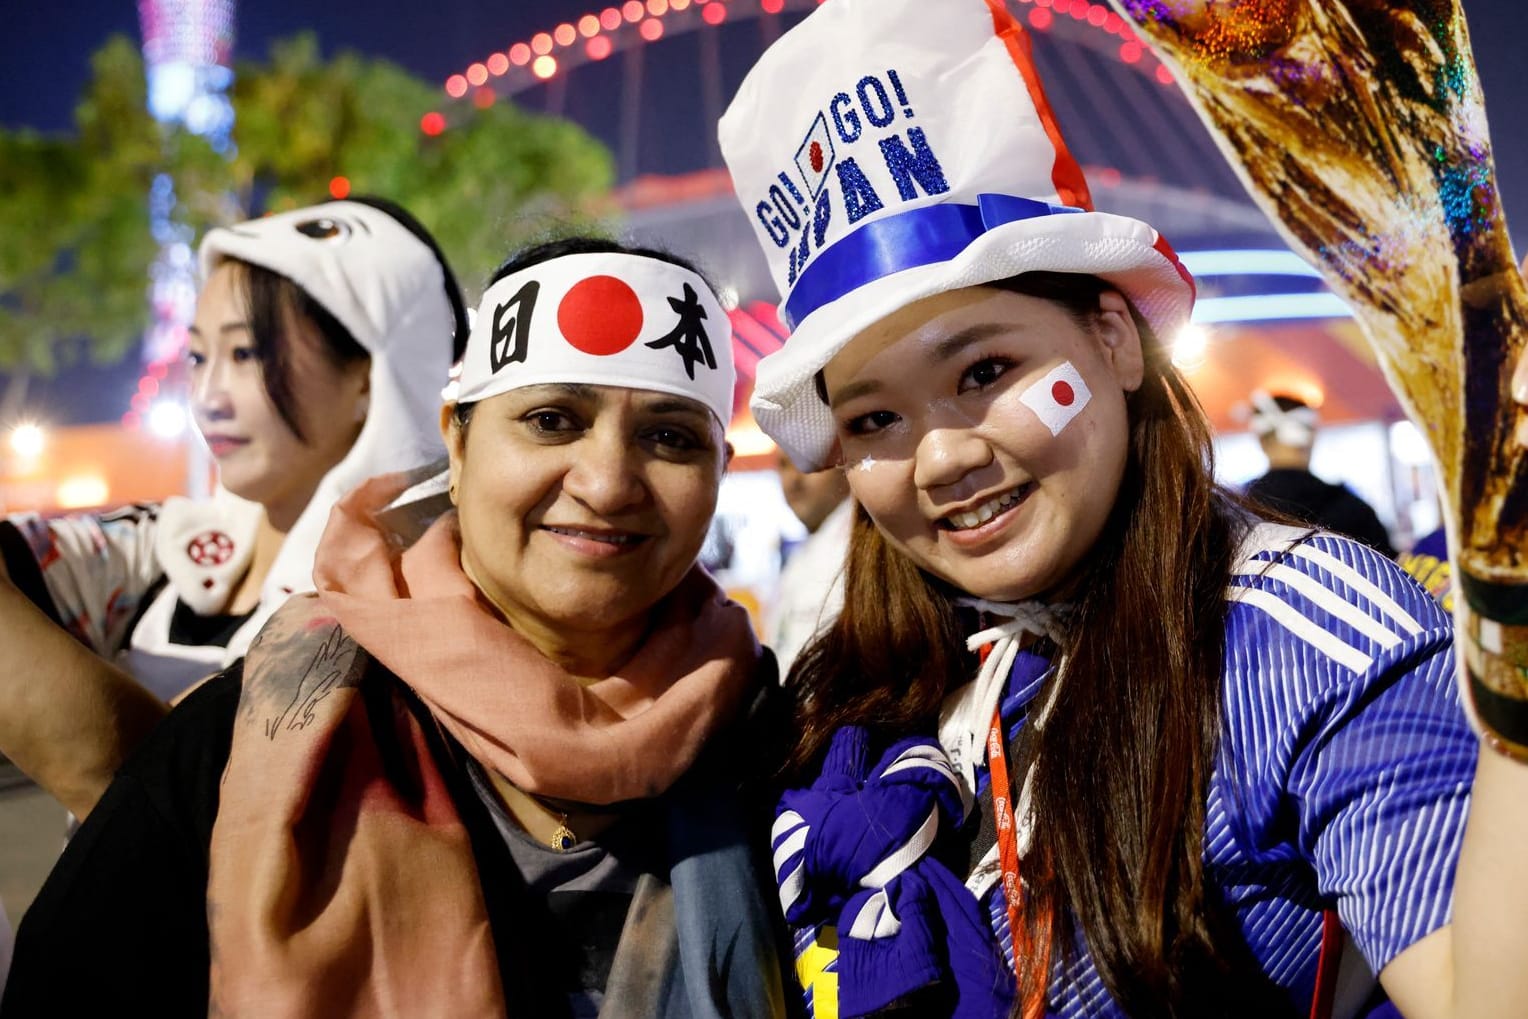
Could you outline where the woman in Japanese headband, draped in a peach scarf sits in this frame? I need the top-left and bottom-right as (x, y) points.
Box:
(0, 240), (784, 1017)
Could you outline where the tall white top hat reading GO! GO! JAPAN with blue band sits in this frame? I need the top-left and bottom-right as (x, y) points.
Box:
(720, 0), (1193, 469)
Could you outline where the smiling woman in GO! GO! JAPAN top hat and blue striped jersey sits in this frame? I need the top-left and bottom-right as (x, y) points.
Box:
(721, 0), (1528, 1019)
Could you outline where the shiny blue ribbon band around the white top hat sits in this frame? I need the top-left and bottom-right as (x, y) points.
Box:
(785, 194), (1085, 330)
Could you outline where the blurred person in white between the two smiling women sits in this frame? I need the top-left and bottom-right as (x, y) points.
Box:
(764, 452), (854, 680)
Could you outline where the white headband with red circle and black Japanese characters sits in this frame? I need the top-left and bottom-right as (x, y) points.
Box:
(448, 252), (735, 428)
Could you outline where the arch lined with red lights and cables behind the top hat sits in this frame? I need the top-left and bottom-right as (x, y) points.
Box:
(435, 0), (1268, 235)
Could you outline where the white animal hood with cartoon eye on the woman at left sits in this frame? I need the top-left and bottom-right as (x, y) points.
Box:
(199, 199), (466, 610)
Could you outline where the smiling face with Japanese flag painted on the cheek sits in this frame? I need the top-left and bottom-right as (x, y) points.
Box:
(822, 287), (1143, 600)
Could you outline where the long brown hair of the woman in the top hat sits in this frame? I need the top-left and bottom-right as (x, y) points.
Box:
(787, 272), (1293, 1016)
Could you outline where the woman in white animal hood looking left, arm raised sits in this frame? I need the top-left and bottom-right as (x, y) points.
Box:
(0, 200), (466, 816)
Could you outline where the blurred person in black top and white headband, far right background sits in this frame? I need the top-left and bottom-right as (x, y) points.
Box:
(1247, 390), (1395, 558)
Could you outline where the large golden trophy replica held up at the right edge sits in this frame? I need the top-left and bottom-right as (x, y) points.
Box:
(1109, 0), (1528, 759)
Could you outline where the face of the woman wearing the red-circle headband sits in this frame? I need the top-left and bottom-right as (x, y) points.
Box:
(443, 385), (727, 640)
